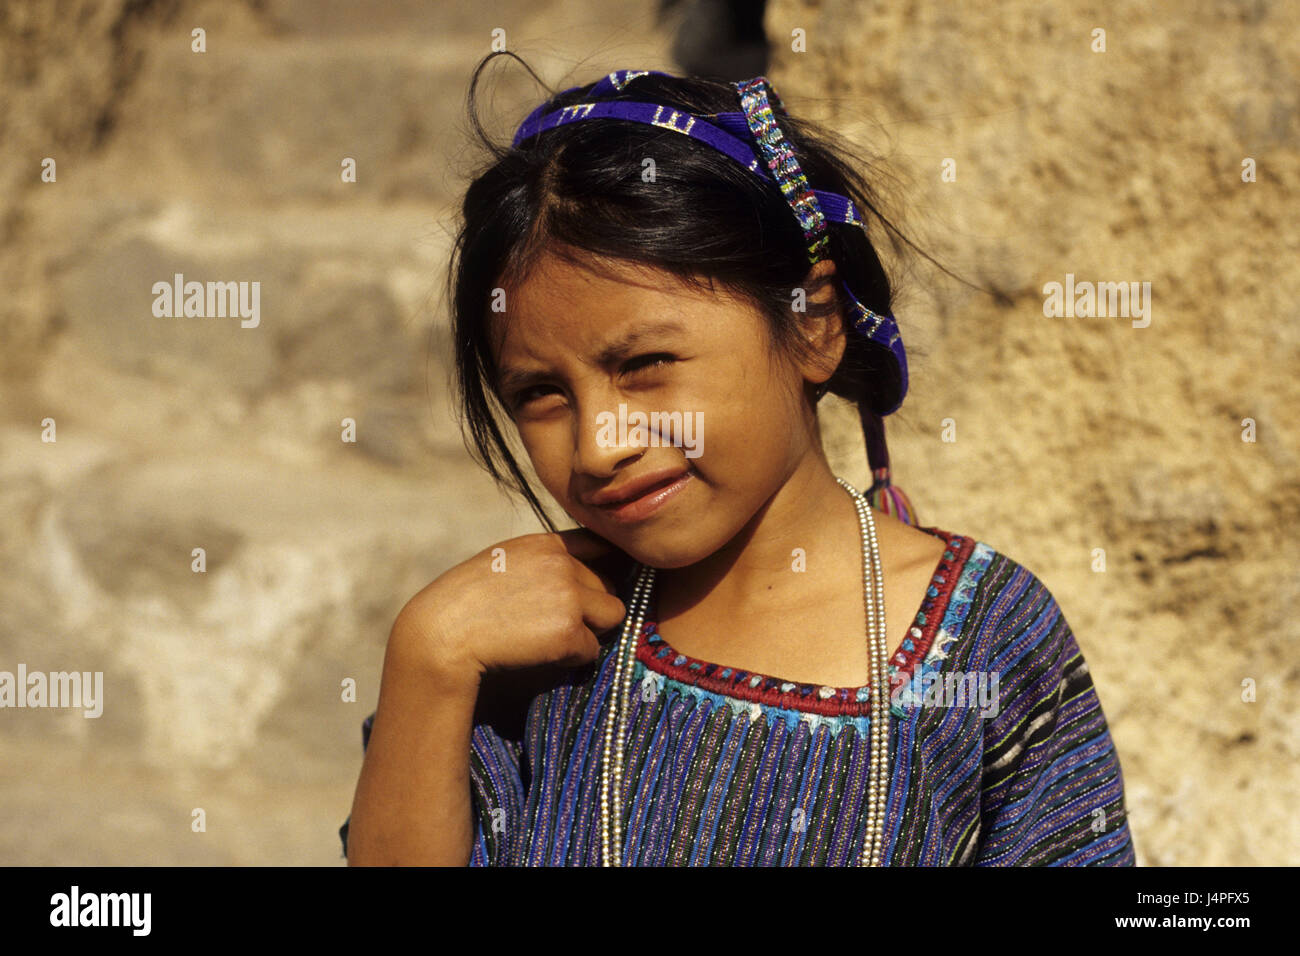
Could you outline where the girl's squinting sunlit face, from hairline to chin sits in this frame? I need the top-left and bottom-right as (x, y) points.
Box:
(494, 254), (844, 568)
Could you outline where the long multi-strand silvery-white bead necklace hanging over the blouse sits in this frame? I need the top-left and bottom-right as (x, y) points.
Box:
(601, 476), (889, 866)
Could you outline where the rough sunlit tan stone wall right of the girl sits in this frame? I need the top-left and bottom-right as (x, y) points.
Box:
(767, 0), (1300, 866)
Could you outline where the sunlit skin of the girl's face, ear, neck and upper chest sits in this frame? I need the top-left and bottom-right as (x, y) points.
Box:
(494, 243), (944, 687)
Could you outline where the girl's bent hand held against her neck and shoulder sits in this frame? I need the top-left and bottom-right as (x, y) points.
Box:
(390, 528), (628, 682)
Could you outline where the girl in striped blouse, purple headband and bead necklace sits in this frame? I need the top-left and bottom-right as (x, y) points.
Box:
(341, 56), (1134, 866)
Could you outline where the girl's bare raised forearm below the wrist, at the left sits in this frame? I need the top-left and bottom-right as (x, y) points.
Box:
(348, 636), (480, 866)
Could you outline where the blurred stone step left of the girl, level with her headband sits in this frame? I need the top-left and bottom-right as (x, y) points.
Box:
(114, 36), (536, 203)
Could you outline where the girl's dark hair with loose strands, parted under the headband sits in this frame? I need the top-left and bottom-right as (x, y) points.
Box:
(447, 52), (967, 531)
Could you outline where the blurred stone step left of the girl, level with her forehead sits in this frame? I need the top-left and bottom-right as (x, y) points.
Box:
(34, 196), (450, 407)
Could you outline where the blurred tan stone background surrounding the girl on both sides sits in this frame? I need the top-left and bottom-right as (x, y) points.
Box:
(0, 0), (1300, 866)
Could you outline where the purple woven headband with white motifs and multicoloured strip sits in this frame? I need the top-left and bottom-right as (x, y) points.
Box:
(511, 70), (907, 415)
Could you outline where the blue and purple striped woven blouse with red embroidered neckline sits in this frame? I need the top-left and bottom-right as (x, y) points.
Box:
(339, 527), (1135, 866)
